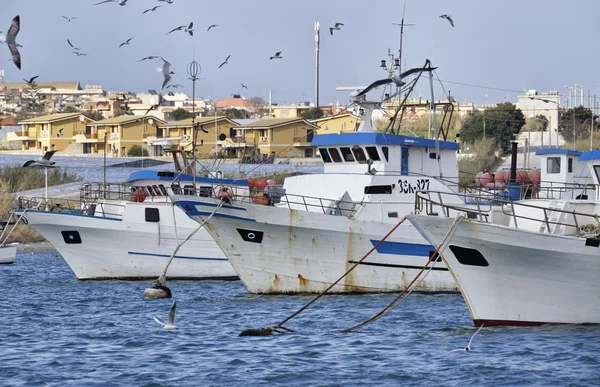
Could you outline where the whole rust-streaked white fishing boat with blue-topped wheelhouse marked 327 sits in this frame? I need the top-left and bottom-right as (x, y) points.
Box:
(172, 64), (474, 293)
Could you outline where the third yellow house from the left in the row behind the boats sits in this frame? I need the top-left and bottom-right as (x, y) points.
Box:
(154, 116), (238, 156)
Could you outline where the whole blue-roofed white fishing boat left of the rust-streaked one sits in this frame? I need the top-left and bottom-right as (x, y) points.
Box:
(17, 170), (248, 279)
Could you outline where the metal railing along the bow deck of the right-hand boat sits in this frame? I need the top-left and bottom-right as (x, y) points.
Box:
(415, 191), (600, 236)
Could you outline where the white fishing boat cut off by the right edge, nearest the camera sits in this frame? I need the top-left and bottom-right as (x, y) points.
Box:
(408, 151), (600, 326)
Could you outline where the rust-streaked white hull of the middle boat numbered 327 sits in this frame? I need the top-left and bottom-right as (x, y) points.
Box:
(174, 196), (458, 293)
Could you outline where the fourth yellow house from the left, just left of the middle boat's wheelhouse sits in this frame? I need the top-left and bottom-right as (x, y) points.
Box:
(223, 118), (319, 157)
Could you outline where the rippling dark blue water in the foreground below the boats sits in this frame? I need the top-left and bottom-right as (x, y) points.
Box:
(0, 253), (600, 386)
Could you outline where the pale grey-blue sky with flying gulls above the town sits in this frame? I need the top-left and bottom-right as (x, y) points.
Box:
(0, 0), (600, 105)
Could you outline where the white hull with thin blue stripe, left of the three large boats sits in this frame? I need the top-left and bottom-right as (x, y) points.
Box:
(19, 203), (237, 279)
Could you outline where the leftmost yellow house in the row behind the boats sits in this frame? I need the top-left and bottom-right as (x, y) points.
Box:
(6, 113), (94, 154)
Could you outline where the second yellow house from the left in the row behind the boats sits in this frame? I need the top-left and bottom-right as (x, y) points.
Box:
(85, 115), (166, 157)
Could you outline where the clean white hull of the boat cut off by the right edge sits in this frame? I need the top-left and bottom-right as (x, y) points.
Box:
(410, 216), (600, 326)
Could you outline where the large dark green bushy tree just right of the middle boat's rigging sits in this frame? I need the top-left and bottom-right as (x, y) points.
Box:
(460, 102), (525, 148)
